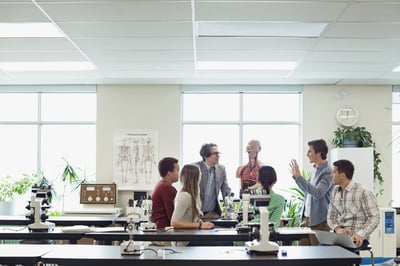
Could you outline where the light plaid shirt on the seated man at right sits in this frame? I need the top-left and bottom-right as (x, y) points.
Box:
(328, 181), (380, 239)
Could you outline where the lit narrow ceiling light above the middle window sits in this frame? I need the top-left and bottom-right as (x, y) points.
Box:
(197, 61), (297, 70)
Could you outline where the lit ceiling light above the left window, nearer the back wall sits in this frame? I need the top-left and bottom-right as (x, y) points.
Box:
(0, 61), (96, 71)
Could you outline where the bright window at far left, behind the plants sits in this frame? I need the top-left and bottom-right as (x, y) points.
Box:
(0, 86), (96, 213)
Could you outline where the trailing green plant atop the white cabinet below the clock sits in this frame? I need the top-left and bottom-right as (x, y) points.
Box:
(332, 127), (383, 195)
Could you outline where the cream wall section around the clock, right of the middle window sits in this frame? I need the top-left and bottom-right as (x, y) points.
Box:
(303, 85), (392, 207)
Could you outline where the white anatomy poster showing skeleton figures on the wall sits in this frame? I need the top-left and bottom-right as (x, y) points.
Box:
(114, 129), (159, 191)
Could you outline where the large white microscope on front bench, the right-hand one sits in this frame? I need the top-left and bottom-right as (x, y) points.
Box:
(246, 195), (279, 254)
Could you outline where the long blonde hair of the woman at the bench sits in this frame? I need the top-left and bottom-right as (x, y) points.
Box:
(180, 164), (200, 217)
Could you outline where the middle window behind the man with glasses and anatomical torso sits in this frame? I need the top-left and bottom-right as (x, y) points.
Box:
(180, 86), (301, 196)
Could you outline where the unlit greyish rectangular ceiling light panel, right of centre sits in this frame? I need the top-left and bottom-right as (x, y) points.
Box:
(196, 21), (328, 38)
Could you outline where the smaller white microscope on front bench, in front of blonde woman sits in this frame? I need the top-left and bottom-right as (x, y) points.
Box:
(121, 208), (143, 255)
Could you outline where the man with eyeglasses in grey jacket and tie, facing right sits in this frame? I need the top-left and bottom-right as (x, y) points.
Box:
(195, 143), (231, 219)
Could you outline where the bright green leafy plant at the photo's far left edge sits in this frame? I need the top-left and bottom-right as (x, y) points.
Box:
(0, 174), (37, 201)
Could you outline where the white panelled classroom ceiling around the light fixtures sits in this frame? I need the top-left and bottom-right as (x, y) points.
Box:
(0, 0), (400, 85)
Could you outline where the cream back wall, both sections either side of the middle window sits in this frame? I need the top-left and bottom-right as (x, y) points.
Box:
(96, 85), (392, 207)
